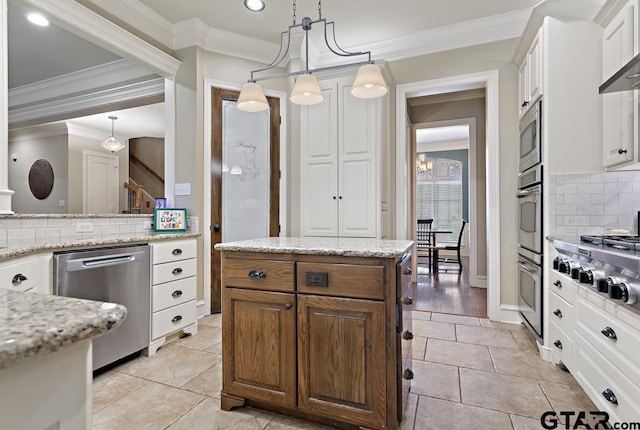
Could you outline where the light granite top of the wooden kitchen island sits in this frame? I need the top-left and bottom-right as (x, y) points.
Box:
(214, 237), (413, 258)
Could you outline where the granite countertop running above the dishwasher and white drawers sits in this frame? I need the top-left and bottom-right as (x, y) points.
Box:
(0, 233), (200, 262)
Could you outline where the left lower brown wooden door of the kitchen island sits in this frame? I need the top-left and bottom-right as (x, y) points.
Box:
(222, 288), (296, 407)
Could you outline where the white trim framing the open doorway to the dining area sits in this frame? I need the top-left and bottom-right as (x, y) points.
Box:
(395, 70), (501, 320)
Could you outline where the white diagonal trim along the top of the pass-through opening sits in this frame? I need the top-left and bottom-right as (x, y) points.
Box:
(22, 0), (182, 77)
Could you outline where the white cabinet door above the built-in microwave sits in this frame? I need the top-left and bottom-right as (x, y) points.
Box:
(518, 27), (544, 116)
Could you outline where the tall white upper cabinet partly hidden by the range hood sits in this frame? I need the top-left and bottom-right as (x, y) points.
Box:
(601, 0), (640, 168)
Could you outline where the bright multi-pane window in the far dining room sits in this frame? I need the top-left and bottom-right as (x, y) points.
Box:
(416, 153), (463, 242)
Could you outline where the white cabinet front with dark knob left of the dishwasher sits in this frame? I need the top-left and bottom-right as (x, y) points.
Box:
(0, 253), (53, 294)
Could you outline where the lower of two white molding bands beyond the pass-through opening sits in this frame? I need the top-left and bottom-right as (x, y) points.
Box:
(9, 78), (165, 124)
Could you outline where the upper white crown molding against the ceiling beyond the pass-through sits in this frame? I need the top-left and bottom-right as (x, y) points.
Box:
(9, 59), (156, 109)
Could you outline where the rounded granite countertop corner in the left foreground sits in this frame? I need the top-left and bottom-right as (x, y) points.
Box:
(0, 288), (127, 369)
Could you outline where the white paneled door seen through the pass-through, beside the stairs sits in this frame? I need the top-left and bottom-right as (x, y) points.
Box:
(82, 150), (120, 214)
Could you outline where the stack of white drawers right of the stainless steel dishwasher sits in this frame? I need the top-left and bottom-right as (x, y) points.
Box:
(147, 239), (198, 355)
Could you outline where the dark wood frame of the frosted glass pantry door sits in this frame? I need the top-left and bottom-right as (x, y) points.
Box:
(211, 88), (280, 312)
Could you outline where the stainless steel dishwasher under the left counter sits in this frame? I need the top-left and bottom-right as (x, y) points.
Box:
(54, 245), (151, 370)
